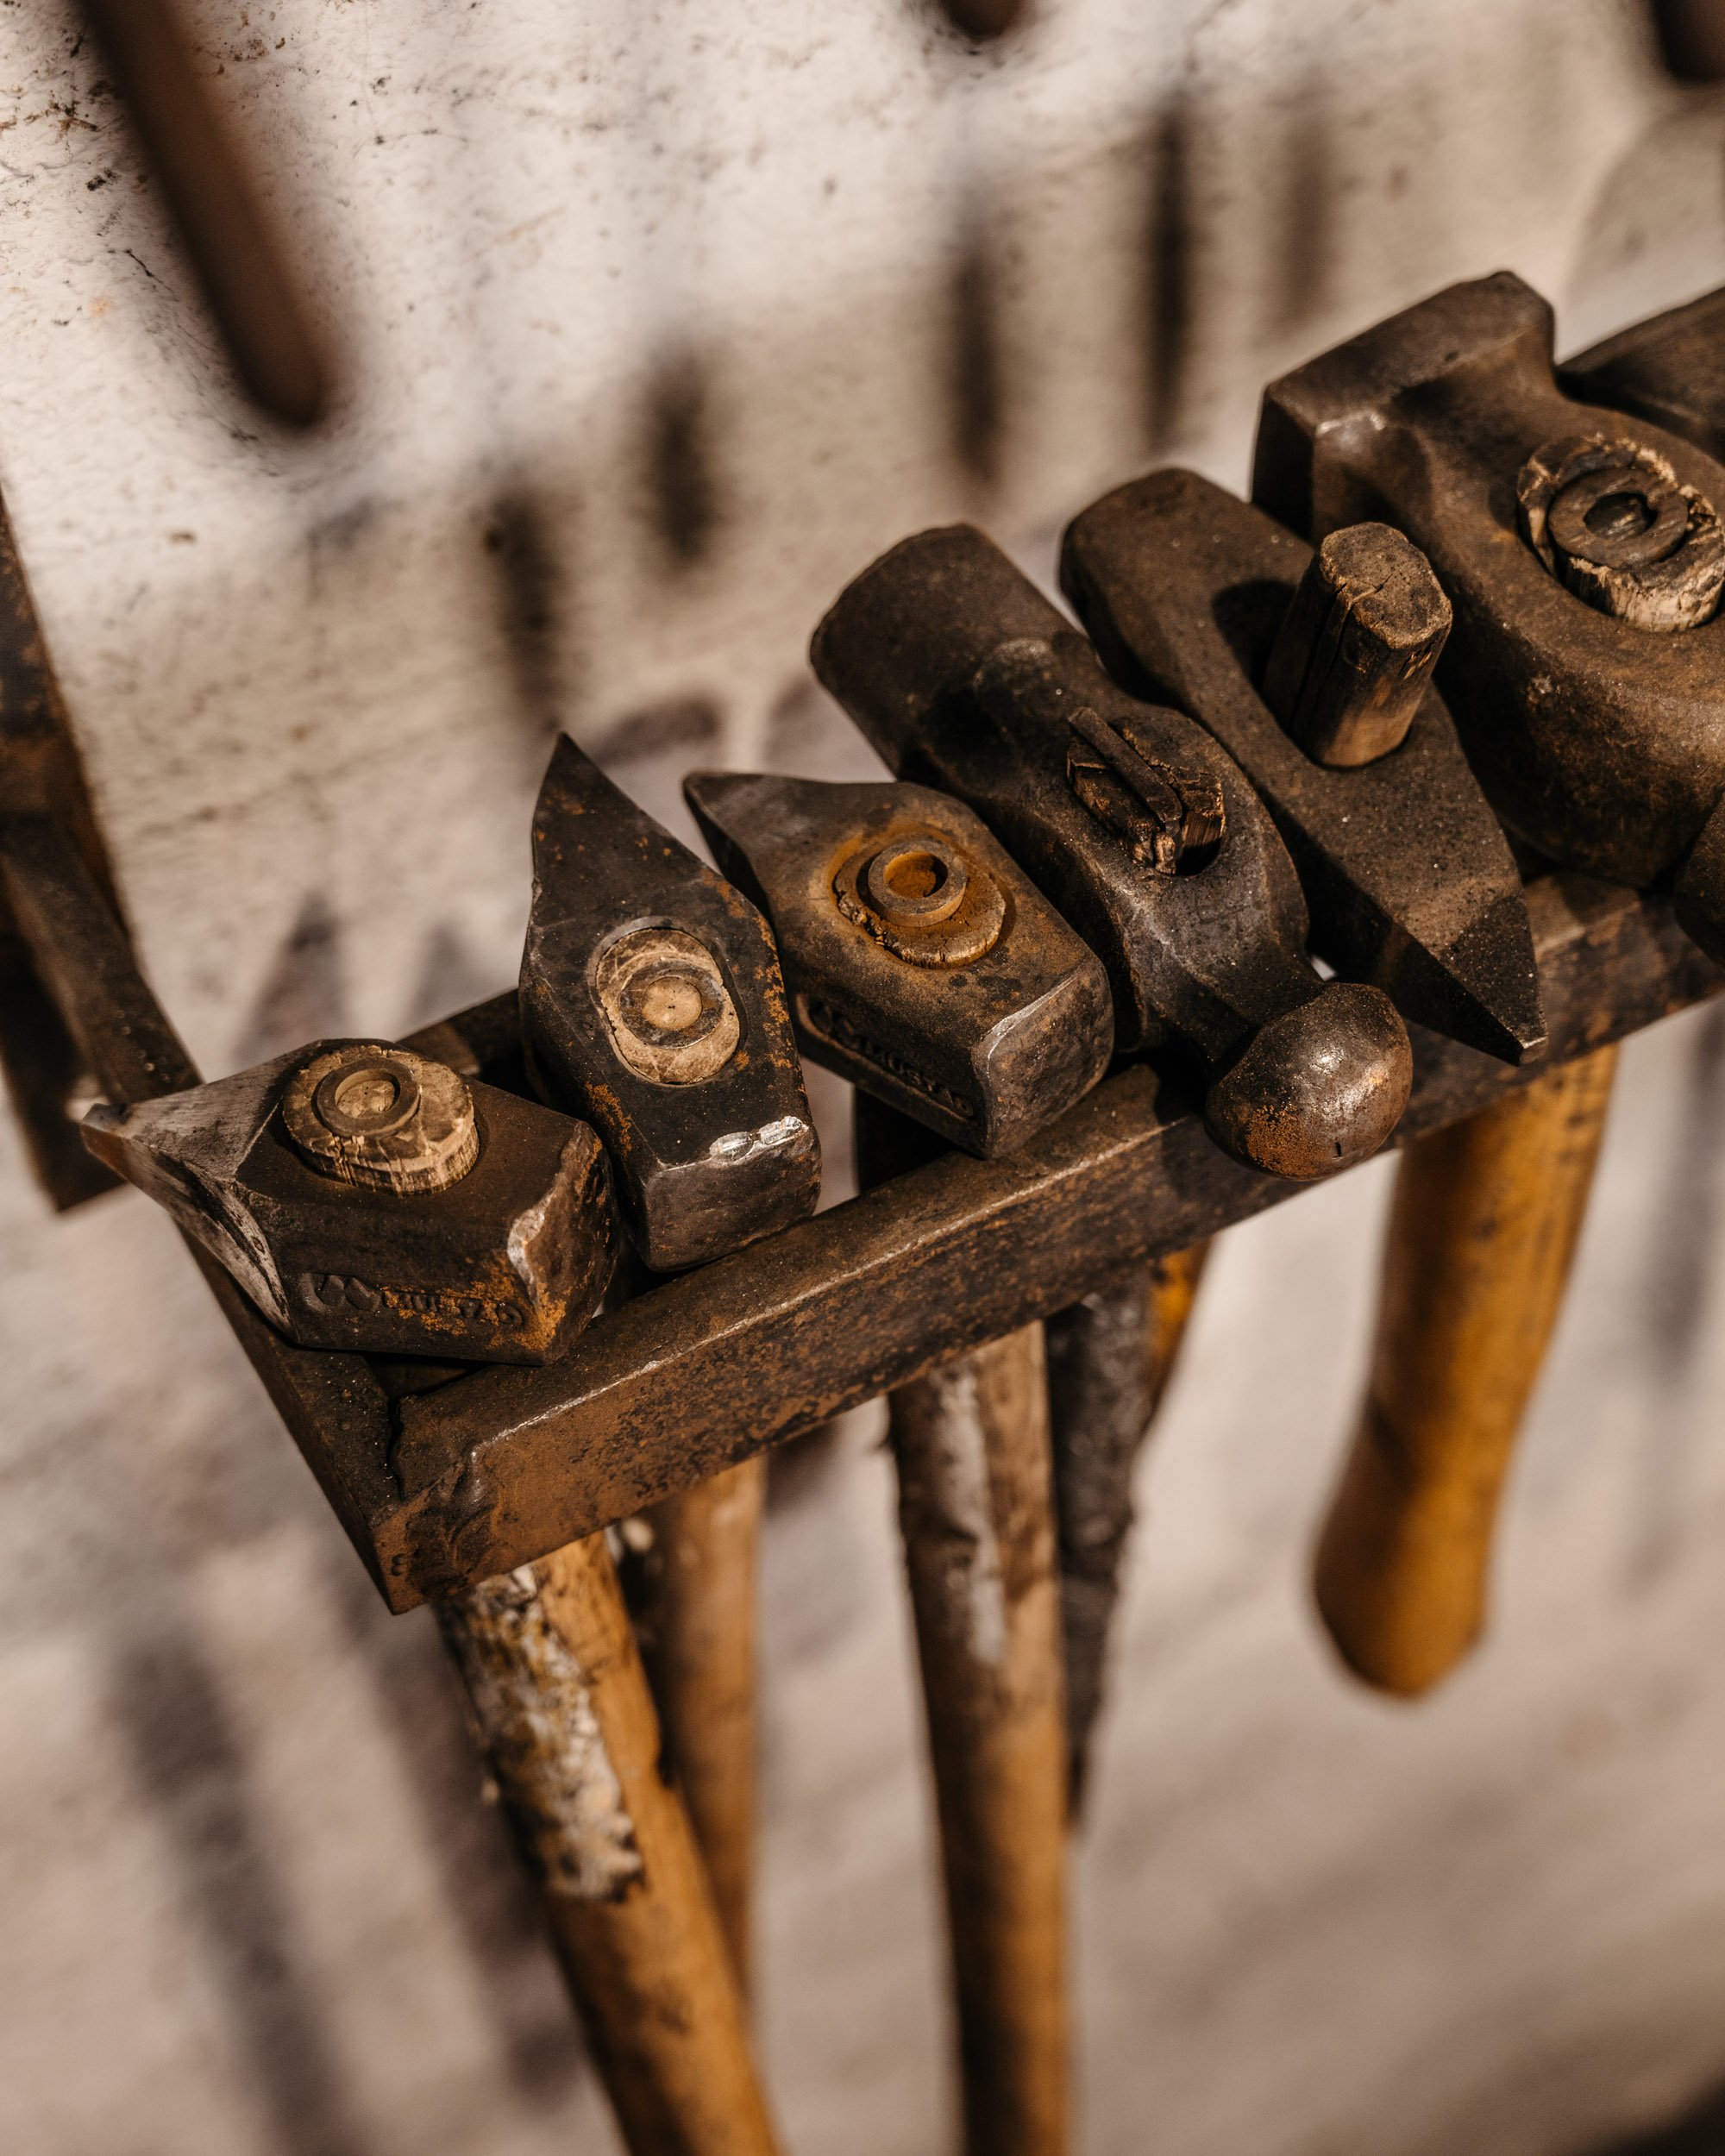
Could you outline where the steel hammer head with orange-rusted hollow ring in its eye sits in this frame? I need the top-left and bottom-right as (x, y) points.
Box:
(684, 772), (1115, 1158)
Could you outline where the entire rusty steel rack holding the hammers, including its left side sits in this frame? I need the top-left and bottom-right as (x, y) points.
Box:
(0, 759), (1725, 1611)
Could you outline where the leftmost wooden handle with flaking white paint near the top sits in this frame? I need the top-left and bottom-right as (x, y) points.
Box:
(438, 1535), (776, 2156)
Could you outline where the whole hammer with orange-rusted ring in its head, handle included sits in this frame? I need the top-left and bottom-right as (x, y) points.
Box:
(684, 774), (1113, 2156)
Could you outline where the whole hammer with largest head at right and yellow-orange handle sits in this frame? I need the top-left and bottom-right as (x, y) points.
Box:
(1253, 274), (1725, 1693)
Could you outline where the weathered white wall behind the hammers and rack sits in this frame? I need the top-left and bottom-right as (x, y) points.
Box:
(0, 0), (1725, 2156)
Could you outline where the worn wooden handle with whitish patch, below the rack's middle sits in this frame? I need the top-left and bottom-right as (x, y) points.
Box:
(891, 1326), (1068, 2156)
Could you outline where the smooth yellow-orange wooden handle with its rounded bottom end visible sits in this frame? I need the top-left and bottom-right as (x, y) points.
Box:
(1315, 1048), (1617, 1695)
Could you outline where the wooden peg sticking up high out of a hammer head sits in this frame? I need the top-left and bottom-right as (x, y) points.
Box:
(1264, 524), (1449, 768)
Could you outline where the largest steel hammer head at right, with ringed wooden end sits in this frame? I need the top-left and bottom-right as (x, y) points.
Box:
(1253, 272), (1725, 957)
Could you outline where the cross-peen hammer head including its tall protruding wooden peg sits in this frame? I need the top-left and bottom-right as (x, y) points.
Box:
(1061, 473), (1546, 1063)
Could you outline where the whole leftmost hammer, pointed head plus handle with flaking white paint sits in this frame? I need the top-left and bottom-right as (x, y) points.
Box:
(72, 1022), (776, 2156)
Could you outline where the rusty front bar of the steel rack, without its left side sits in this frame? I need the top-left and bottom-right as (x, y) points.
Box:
(369, 875), (1725, 1608)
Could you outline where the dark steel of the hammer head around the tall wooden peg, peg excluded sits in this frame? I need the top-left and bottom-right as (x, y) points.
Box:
(1061, 473), (1546, 1063)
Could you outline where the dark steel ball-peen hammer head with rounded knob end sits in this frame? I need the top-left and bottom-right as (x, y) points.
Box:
(811, 524), (1413, 1177)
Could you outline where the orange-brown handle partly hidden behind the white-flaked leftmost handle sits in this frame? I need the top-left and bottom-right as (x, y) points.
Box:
(643, 1453), (768, 1992)
